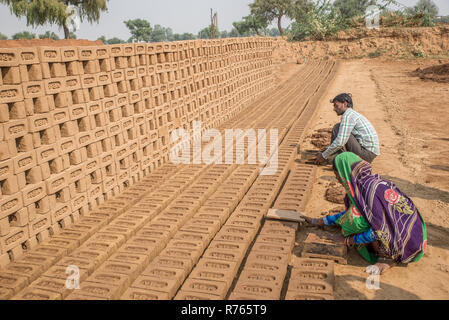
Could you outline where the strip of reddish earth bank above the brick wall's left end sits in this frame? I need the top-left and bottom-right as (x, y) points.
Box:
(0, 39), (103, 48)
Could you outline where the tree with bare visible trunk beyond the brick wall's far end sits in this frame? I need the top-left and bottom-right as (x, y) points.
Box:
(249, 0), (295, 35)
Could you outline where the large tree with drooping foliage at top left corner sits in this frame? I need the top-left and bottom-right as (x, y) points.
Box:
(0, 0), (108, 39)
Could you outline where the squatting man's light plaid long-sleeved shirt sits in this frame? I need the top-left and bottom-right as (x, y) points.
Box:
(323, 108), (380, 159)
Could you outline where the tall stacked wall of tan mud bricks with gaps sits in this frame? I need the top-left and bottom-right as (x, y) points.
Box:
(0, 38), (273, 265)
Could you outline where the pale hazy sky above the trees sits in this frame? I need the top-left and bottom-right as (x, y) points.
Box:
(0, 0), (449, 40)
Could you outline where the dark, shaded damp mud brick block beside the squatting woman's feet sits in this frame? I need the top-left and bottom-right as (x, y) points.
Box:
(301, 233), (348, 264)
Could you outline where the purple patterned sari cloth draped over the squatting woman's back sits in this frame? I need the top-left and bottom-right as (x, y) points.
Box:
(350, 161), (427, 263)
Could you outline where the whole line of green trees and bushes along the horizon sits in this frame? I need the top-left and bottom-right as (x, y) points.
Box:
(0, 0), (449, 44)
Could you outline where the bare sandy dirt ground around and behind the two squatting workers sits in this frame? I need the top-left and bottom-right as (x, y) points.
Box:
(294, 59), (449, 300)
